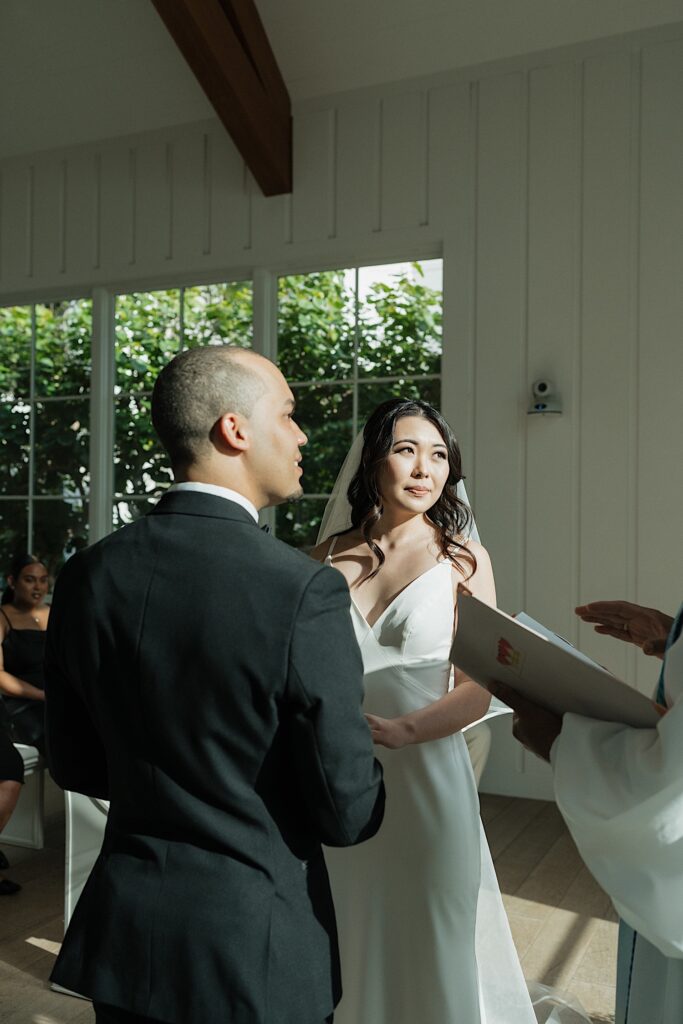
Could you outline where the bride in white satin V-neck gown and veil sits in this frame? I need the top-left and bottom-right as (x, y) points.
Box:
(313, 398), (536, 1024)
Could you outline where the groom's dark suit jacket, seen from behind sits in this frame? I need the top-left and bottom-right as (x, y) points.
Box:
(46, 492), (384, 1024)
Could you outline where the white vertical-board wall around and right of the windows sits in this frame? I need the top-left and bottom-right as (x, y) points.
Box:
(0, 25), (683, 796)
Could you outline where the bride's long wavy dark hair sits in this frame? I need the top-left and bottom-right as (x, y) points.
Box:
(347, 398), (477, 583)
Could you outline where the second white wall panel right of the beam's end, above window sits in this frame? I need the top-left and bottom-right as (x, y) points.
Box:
(335, 101), (380, 239)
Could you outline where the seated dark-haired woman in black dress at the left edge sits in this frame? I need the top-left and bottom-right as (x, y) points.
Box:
(0, 554), (50, 753)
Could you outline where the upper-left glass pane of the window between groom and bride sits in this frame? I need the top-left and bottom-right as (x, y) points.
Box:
(278, 270), (355, 381)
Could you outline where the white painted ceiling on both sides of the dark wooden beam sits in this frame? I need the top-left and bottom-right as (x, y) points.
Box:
(0, 0), (683, 158)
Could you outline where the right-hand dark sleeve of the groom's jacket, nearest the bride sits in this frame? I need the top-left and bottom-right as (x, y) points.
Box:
(288, 567), (384, 846)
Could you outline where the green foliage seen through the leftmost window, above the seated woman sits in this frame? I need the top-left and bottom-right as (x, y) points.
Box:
(0, 300), (92, 575)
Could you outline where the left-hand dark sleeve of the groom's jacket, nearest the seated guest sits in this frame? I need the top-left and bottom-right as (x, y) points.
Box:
(45, 555), (109, 799)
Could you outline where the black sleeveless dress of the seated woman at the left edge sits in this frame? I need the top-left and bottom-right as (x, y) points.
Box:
(0, 608), (47, 754)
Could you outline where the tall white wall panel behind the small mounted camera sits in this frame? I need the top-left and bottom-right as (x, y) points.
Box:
(522, 65), (579, 637)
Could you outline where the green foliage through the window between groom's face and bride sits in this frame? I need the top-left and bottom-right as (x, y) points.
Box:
(276, 263), (442, 547)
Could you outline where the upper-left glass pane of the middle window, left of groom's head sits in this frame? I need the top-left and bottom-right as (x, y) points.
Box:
(116, 289), (180, 393)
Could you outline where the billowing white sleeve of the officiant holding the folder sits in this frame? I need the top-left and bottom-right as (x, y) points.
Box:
(552, 698), (683, 957)
